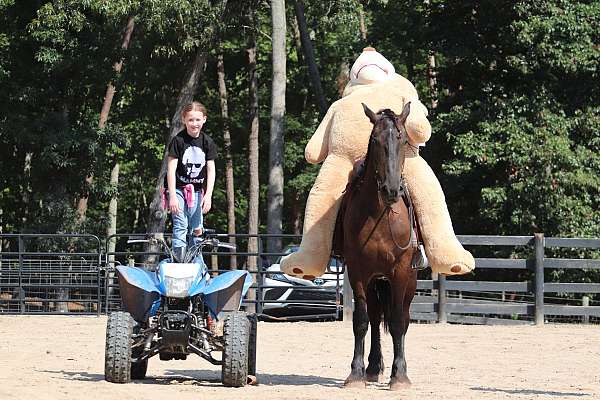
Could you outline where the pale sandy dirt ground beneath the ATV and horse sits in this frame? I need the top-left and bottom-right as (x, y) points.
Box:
(0, 316), (600, 400)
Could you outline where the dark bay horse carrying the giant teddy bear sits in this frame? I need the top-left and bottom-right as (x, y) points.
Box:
(341, 103), (417, 389)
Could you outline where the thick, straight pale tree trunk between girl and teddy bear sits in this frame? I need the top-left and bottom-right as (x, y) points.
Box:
(267, 0), (286, 252)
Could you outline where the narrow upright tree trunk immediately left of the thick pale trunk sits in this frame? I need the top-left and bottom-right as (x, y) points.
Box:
(246, 4), (262, 312)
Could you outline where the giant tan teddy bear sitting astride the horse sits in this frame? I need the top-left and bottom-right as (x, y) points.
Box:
(281, 47), (475, 278)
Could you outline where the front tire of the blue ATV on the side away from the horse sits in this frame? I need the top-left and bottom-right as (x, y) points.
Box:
(104, 311), (134, 383)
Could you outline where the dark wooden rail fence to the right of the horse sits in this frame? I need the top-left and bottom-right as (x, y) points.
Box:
(394, 233), (600, 325)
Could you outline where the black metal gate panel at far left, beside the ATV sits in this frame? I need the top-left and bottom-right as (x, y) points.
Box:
(0, 234), (103, 314)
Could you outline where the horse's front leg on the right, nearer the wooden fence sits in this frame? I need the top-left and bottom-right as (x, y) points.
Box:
(390, 282), (411, 390)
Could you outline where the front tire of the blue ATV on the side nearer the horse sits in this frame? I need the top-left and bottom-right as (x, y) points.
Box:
(221, 311), (250, 387)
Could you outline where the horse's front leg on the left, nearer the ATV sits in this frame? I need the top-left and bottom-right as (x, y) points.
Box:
(344, 288), (369, 388)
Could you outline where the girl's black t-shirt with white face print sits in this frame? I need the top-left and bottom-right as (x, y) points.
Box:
(165, 129), (217, 190)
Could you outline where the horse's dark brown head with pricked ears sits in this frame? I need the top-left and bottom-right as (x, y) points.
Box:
(363, 103), (410, 205)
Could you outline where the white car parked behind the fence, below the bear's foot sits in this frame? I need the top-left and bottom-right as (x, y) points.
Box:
(262, 246), (344, 319)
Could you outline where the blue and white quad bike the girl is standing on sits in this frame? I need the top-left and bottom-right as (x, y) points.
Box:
(104, 230), (256, 387)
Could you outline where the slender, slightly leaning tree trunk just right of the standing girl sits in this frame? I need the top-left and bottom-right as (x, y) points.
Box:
(217, 51), (237, 269)
